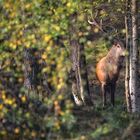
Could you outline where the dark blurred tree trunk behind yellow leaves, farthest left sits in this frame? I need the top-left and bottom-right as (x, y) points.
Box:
(24, 48), (51, 97)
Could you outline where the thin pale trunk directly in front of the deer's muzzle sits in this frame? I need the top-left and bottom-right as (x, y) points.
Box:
(125, 0), (132, 112)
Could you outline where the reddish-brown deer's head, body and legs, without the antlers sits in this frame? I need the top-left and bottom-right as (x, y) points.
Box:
(96, 41), (126, 107)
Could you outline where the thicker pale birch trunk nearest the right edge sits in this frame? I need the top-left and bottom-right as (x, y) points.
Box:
(129, 0), (140, 112)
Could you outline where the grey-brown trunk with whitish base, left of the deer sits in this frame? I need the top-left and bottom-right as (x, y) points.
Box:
(71, 39), (90, 105)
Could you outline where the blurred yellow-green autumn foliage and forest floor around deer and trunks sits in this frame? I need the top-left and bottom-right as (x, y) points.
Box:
(0, 0), (140, 140)
